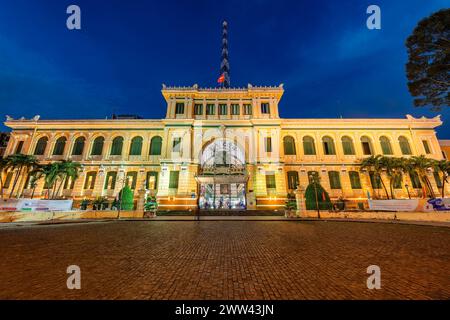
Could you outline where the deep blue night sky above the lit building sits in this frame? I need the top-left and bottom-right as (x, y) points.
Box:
(0, 0), (450, 134)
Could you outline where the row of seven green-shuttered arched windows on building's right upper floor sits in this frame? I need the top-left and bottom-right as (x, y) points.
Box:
(283, 136), (412, 155)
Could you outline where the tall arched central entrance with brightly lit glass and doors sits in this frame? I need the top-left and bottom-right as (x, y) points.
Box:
(196, 139), (248, 210)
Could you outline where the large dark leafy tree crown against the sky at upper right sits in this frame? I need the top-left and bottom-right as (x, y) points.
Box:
(406, 9), (450, 111)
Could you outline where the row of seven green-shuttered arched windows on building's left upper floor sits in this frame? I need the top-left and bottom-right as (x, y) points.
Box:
(33, 136), (162, 156)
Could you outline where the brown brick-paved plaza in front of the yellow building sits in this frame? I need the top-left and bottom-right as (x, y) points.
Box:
(0, 221), (450, 299)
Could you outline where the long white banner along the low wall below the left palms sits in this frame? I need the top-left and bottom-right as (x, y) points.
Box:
(0, 199), (73, 211)
